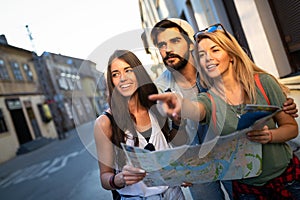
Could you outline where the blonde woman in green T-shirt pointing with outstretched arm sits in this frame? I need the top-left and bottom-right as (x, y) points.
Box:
(149, 24), (300, 199)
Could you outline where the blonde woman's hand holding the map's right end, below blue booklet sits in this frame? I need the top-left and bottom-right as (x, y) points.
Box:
(247, 125), (272, 144)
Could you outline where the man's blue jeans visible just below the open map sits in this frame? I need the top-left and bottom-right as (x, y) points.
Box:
(190, 181), (233, 200)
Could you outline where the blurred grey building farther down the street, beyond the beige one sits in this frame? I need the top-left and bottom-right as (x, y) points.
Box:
(38, 52), (105, 138)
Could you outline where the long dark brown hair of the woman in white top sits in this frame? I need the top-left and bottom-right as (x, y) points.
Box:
(107, 50), (169, 147)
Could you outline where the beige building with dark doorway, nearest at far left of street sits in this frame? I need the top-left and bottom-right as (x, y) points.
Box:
(0, 35), (57, 163)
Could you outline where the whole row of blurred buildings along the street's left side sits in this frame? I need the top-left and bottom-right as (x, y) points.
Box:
(0, 35), (106, 163)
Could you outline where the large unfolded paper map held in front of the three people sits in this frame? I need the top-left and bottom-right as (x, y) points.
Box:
(122, 105), (280, 186)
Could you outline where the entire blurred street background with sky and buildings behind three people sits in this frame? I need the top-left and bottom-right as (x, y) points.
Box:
(0, 0), (300, 200)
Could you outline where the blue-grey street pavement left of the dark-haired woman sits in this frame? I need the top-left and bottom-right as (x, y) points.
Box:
(0, 123), (112, 200)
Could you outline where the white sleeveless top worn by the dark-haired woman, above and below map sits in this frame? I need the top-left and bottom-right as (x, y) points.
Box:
(118, 111), (170, 197)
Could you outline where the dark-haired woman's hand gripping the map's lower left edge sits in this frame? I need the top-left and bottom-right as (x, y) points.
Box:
(120, 165), (146, 185)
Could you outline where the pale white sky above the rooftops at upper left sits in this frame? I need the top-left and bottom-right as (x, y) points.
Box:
(0, 0), (150, 63)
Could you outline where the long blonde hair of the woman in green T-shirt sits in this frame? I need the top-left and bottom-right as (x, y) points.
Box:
(195, 30), (289, 103)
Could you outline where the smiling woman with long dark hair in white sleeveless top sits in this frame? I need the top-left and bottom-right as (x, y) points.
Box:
(94, 50), (185, 200)
